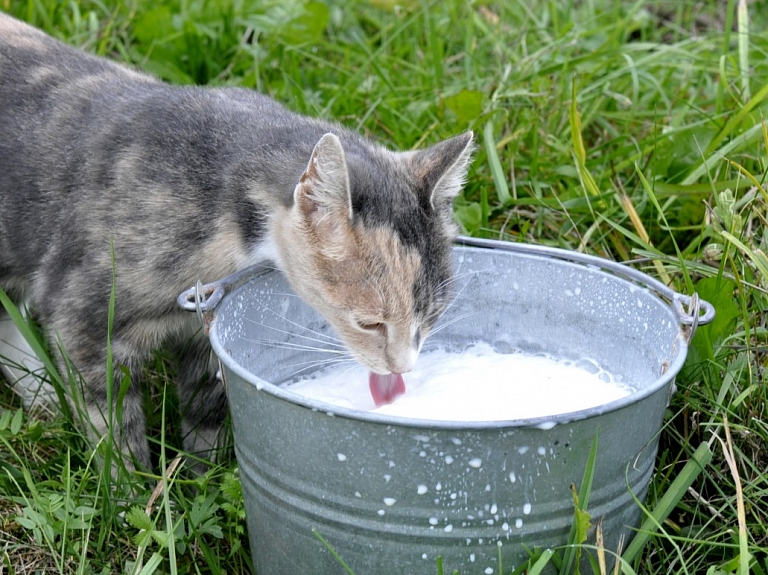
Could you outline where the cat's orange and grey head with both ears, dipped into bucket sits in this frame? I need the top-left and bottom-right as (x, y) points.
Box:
(272, 132), (472, 374)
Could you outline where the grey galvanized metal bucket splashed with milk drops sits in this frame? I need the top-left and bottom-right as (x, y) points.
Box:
(180, 239), (714, 575)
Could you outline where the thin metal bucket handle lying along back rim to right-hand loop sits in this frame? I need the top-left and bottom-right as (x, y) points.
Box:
(456, 236), (715, 340)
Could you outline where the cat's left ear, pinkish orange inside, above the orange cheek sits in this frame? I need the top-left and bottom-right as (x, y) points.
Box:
(293, 132), (352, 221)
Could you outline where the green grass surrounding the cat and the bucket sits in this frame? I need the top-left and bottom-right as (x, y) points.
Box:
(0, 0), (768, 575)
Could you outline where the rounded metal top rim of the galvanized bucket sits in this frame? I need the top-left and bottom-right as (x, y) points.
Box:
(209, 238), (688, 431)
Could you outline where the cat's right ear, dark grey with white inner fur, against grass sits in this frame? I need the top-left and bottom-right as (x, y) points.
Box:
(408, 131), (474, 210)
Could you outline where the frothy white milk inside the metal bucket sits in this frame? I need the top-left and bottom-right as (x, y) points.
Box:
(287, 343), (631, 421)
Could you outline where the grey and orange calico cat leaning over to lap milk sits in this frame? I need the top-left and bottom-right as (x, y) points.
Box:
(0, 14), (473, 468)
